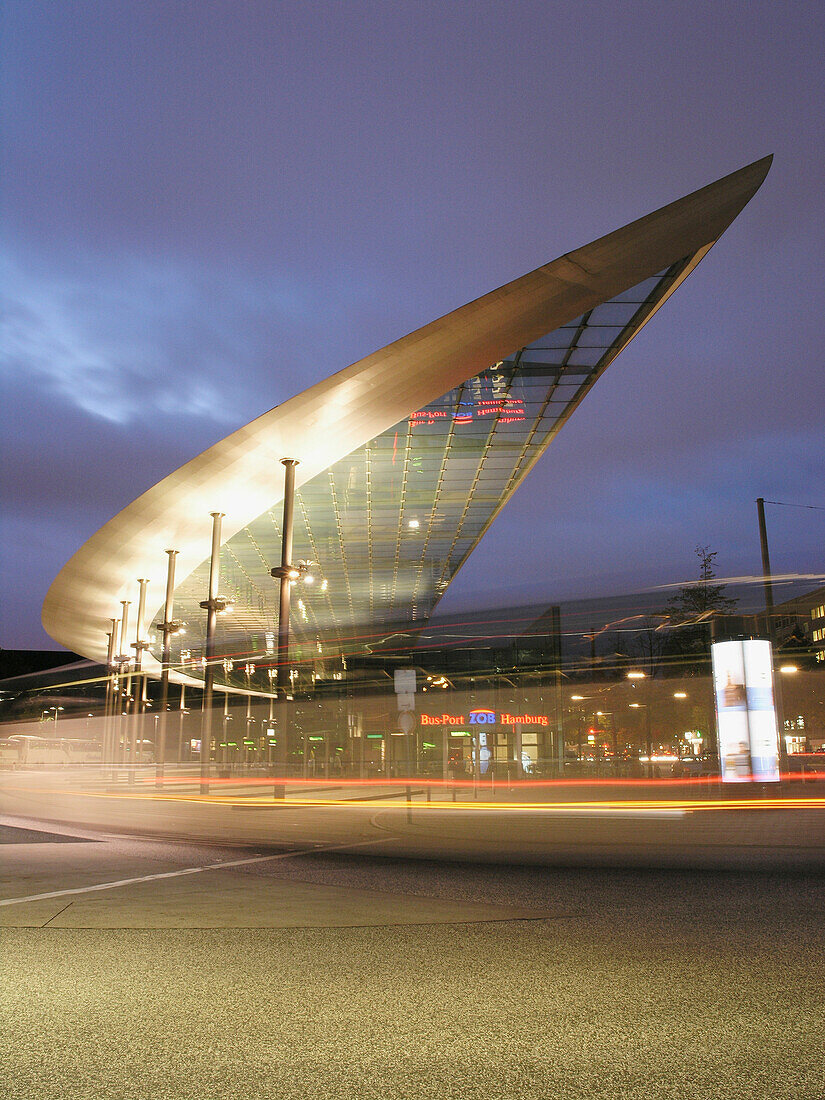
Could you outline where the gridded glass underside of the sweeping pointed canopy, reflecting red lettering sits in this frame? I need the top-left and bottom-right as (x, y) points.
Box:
(153, 257), (690, 679)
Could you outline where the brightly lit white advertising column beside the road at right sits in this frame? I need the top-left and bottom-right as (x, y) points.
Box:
(711, 638), (779, 783)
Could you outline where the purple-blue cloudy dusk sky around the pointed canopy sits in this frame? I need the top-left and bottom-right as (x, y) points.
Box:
(0, 0), (825, 648)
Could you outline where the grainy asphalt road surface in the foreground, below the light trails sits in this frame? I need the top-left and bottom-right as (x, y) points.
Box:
(0, 820), (825, 1100)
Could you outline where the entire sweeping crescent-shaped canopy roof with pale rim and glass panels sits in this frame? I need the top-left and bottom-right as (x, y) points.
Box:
(43, 157), (771, 678)
